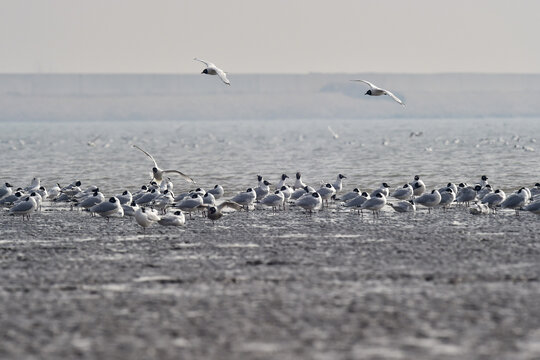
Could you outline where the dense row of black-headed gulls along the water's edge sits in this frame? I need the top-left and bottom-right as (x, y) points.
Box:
(0, 145), (540, 229)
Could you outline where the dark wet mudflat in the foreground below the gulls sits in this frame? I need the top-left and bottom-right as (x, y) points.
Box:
(0, 207), (540, 359)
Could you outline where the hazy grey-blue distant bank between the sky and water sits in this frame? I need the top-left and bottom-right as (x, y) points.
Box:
(0, 73), (540, 121)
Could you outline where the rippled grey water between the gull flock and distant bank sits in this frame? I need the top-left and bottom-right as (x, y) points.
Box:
(0, 119), (540, 194)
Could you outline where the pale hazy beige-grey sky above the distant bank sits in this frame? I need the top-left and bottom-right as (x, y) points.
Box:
(0, 0), (540, 74)
